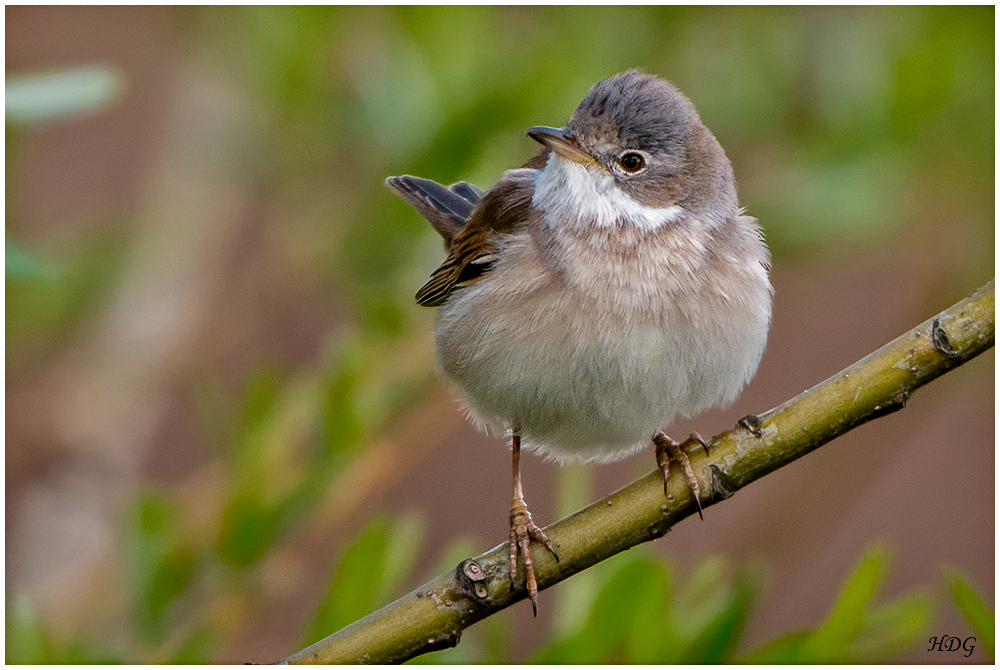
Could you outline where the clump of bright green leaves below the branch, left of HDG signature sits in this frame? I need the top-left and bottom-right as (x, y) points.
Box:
(532, 550), (930, 664)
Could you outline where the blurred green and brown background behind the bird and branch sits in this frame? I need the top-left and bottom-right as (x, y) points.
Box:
(5, 7), (995, 663)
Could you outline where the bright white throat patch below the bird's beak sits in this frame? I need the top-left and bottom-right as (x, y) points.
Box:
(531, 154), (685, 232)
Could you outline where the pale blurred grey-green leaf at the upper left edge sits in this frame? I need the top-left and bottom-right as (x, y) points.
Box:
(4, 66), (123, 123)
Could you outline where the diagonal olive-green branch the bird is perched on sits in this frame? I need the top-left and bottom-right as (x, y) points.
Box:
(286, 281), (994, 663)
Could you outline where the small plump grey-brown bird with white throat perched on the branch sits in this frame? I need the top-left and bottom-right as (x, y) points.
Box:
(386, 70), (773, 614)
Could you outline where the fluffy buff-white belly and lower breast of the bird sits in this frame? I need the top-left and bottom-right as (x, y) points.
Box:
(436, 234), (770, 461)
